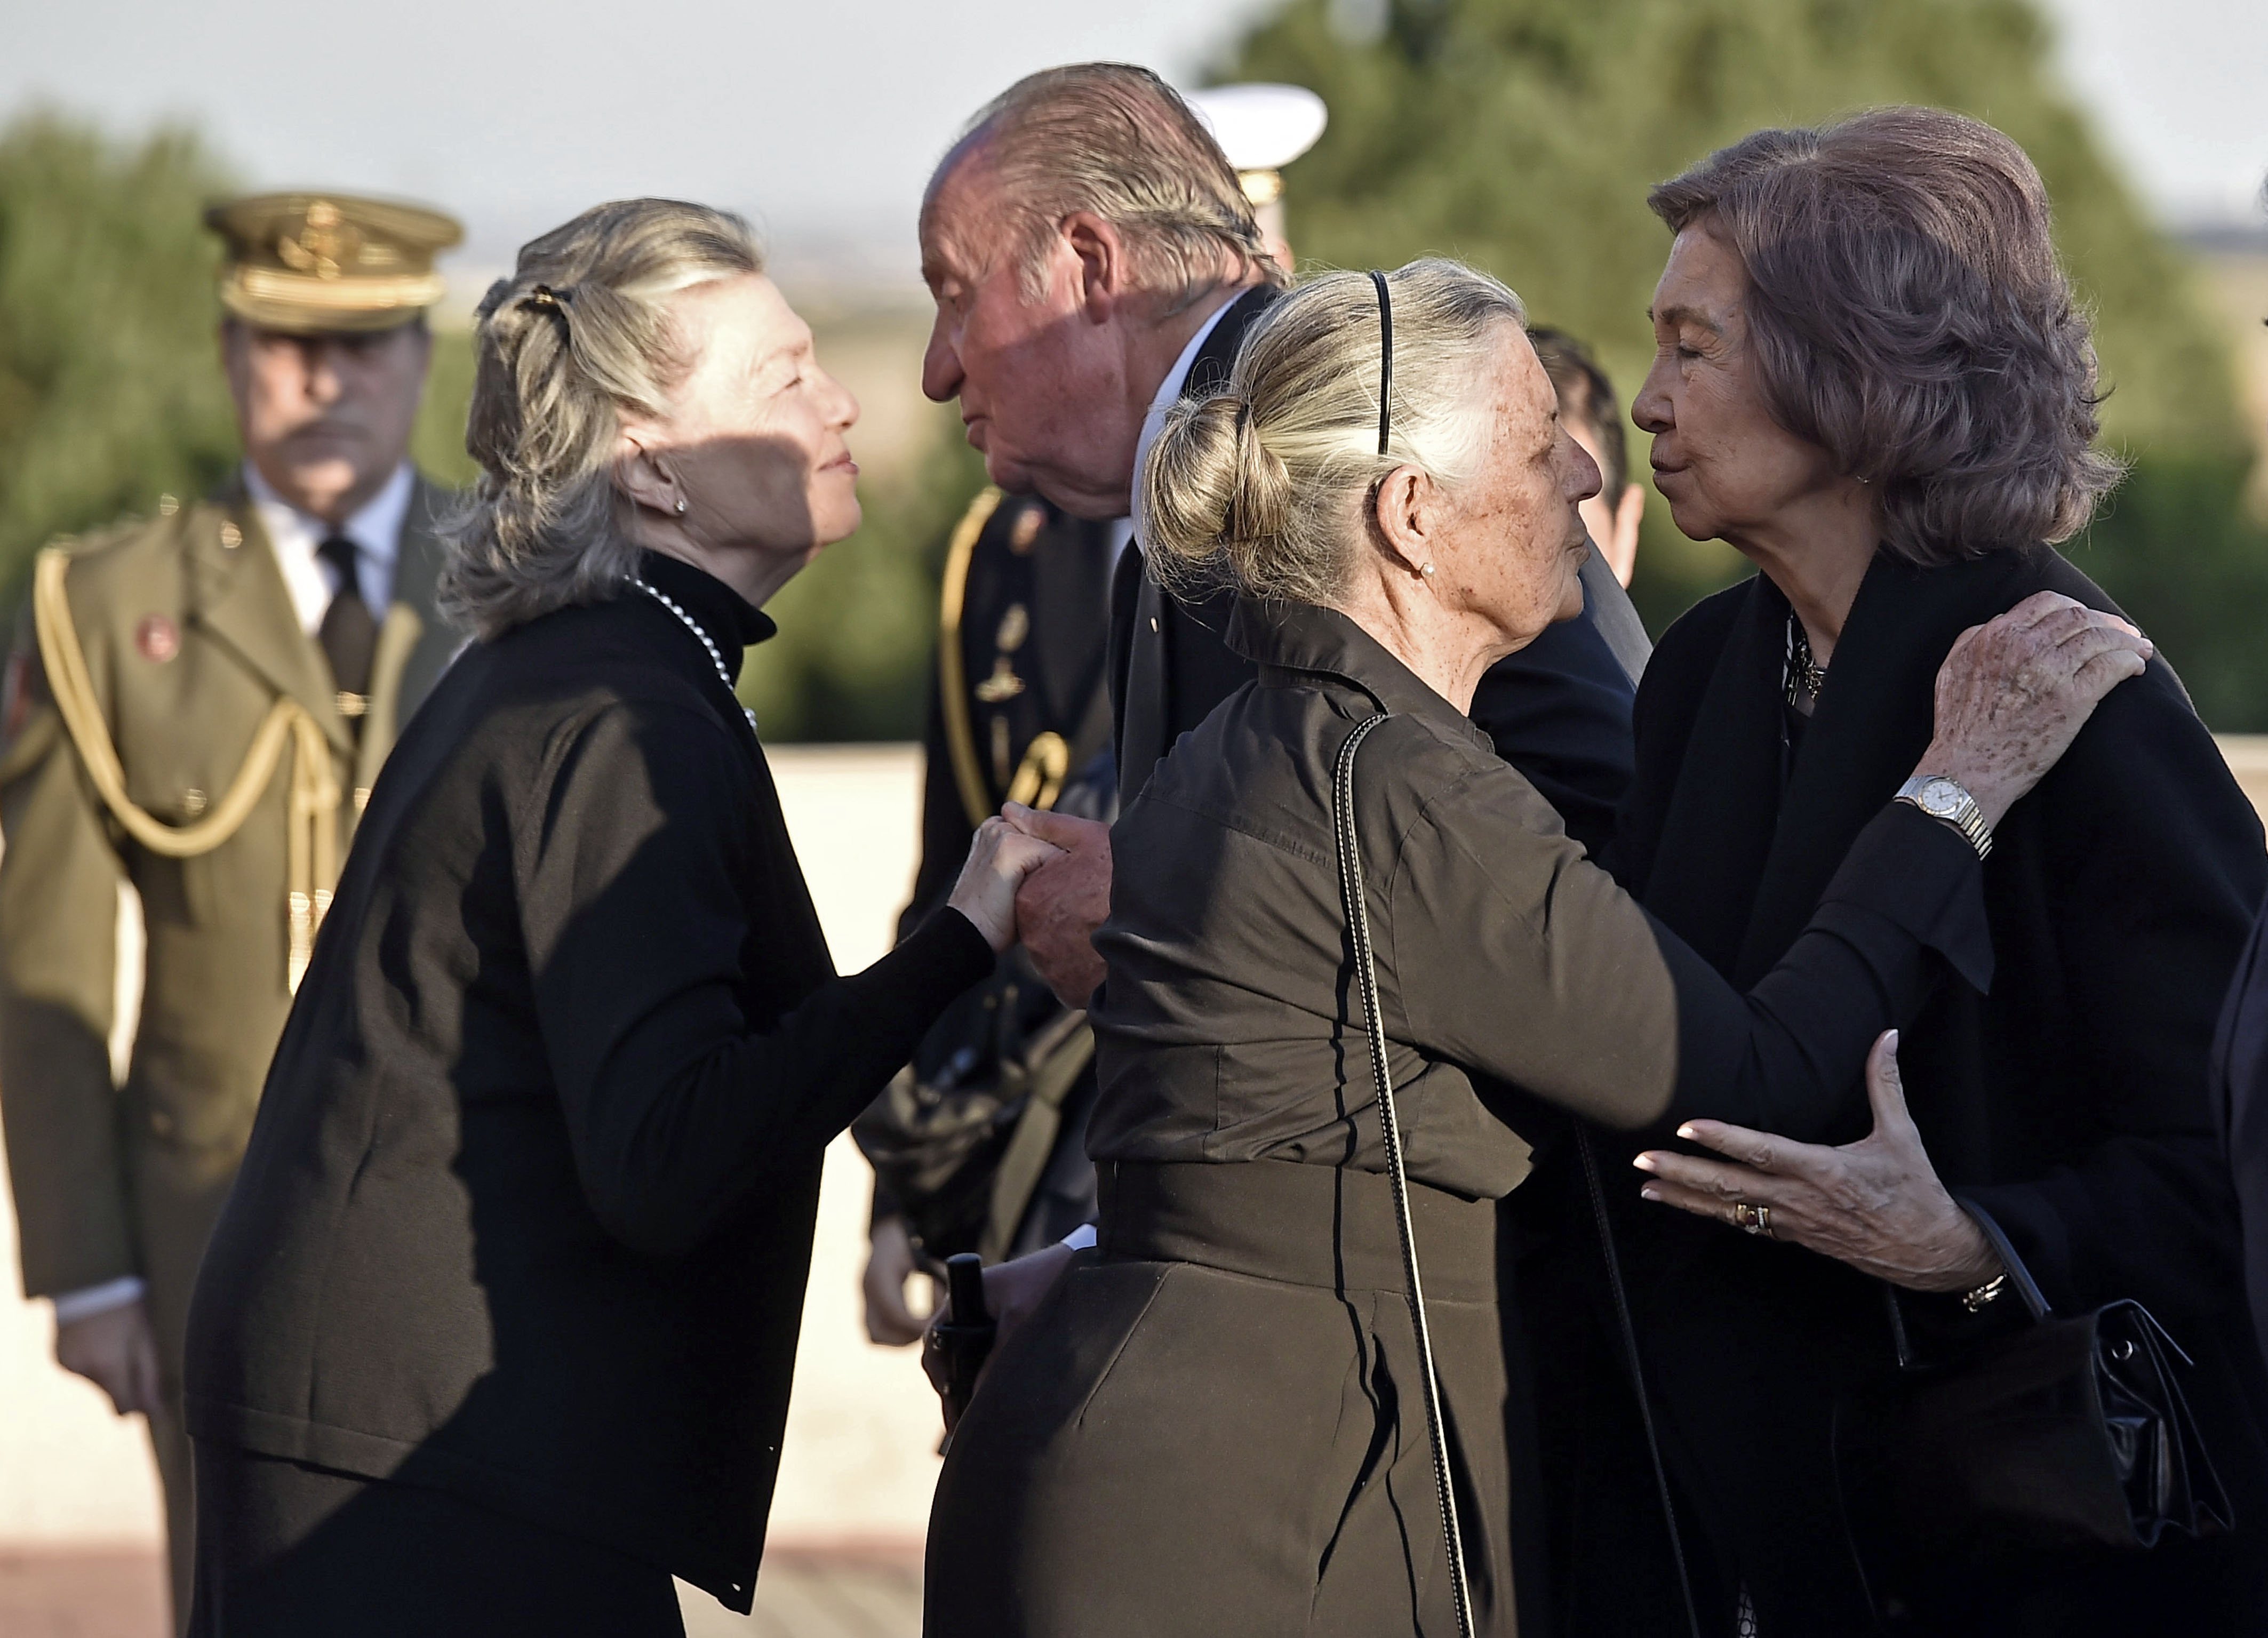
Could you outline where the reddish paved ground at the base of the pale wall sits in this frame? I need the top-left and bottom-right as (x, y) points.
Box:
(0, 1549), (921, 1638)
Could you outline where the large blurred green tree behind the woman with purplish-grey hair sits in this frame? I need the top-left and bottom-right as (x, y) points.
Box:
(1220, 0), (2268, 728)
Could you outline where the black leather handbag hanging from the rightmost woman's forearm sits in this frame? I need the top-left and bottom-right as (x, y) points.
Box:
(1835, 1205), (2234, 1615)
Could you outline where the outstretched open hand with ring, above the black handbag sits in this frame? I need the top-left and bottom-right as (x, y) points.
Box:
(1631, 1030), (2000, 1291)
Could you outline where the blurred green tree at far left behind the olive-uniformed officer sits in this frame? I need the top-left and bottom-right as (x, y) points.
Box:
(0, 114), (238, 603)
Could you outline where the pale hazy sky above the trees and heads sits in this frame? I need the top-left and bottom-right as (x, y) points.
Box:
(0, 0), (2268, 281)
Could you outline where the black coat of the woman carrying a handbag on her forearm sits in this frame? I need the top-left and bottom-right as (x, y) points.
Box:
(1608, 549), (2268, 1633)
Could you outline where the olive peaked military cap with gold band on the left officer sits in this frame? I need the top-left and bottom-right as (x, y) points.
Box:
(204, 193), (465, 333)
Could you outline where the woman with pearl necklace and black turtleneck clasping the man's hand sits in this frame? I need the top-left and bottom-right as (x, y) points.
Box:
(188, 199), (1052, 1638)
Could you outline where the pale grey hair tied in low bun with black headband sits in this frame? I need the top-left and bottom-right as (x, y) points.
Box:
(1141, 261), (1527, 603)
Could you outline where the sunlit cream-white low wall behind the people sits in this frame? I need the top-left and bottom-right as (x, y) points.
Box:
(0, 746), (939, 1547)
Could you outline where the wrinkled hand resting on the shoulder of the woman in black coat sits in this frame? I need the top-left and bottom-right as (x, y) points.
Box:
(1914, 592), (2154, 826)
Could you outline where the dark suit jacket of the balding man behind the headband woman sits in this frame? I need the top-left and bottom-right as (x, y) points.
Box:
(1109, 286), (1647, 856)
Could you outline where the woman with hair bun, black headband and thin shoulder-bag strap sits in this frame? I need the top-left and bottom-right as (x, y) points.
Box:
(925, 261), (2145, 1638)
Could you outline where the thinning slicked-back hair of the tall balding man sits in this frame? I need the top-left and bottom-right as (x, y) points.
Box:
(923, 63), (1288, 315)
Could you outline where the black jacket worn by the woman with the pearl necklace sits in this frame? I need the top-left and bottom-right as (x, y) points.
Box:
(188, 554), (991, 1611)
